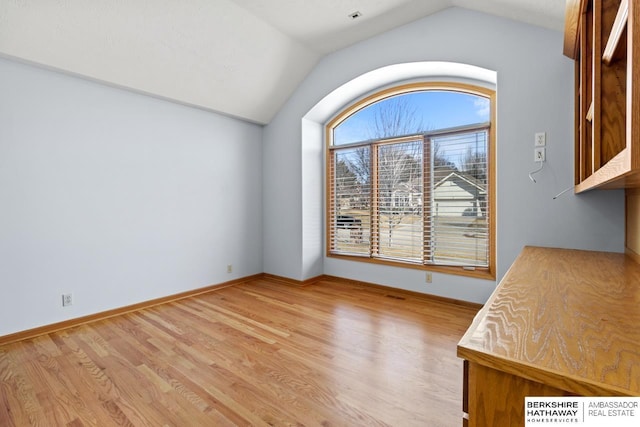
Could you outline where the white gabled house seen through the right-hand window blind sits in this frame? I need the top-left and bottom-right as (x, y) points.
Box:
(433, 172), (487, 217)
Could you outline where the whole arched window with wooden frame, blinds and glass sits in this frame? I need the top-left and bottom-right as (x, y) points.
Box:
(326, 83), (495, 277)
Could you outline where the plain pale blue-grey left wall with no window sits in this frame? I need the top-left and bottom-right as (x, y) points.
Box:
(0, 59), (263, 335)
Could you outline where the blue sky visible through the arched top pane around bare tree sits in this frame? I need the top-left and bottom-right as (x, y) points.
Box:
(334, 91), (489, 145)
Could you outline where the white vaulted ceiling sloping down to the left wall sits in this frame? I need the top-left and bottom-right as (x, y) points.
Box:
(0, 0), (564, 123)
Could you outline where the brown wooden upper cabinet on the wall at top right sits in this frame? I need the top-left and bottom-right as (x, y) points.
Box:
(564, 0), (640, 192)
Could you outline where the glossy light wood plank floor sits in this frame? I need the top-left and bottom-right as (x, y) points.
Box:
(0, 279), (476, 427)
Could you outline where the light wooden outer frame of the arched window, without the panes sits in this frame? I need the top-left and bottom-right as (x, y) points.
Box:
(325, 81), (497, 280)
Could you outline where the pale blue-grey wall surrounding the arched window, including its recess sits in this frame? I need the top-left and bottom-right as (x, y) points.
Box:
(263, 8), (624, 302)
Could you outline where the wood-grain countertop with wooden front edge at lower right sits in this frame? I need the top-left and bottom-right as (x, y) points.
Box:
(458, 247), (640, 396)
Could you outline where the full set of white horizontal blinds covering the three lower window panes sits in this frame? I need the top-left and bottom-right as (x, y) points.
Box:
(329, 124), (490, 267)
